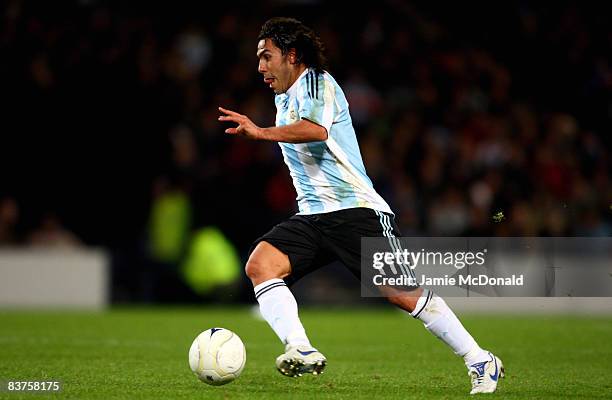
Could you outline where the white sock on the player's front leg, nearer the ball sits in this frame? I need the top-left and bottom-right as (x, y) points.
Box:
(254, 278), (310, 346)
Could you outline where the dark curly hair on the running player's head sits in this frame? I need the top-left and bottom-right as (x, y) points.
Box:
(257, 17), (327, 73)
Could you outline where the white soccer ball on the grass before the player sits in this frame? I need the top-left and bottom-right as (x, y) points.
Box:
(189, 328), (246, 386)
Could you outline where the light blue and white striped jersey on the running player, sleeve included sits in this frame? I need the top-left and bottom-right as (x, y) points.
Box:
(274, 68), (392, 214)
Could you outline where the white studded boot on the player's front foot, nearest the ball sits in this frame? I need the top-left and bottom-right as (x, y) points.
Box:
(276, 345), (327, 378)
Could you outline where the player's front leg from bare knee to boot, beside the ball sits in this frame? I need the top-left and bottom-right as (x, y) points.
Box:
(246, 241), (327, 377)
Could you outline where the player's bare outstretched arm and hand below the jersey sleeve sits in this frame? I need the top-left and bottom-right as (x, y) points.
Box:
(219, 107), (327, 143)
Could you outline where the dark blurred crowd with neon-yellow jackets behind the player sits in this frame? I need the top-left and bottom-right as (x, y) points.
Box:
(0, 0), (612, 301)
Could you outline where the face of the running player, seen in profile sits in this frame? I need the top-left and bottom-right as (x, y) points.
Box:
(257, 39), (295, 94)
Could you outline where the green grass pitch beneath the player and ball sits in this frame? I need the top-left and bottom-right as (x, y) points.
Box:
(0, 307), (612, 400)
